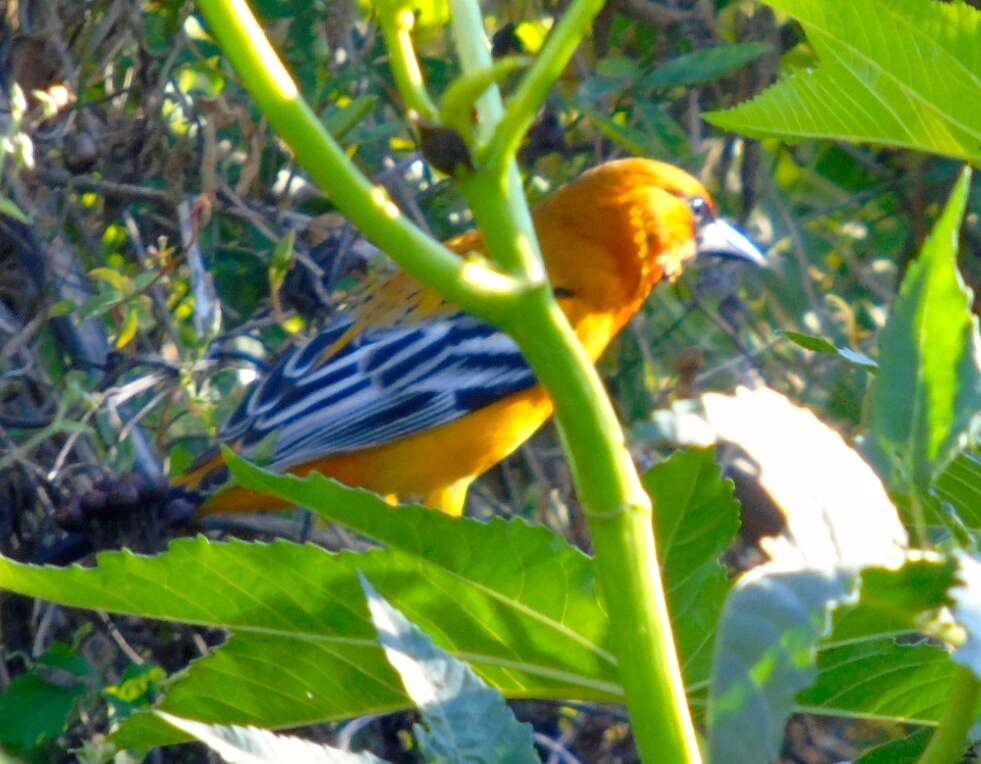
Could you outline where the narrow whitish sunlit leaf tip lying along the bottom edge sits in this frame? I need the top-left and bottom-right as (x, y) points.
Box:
(157, 712), (385, 764)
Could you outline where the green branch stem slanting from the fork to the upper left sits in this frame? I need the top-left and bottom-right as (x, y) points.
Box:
(199, 0), (525, 322)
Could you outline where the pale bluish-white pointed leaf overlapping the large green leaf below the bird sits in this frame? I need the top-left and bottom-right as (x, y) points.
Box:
(359, 575), (540, 764)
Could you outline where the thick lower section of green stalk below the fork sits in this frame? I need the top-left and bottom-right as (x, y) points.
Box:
(514, 292), (701, 764)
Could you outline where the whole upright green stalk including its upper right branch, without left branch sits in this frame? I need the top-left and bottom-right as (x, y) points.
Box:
(453, 0), (701, 764)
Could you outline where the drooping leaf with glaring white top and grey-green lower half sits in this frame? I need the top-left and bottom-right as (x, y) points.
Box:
(702, 388), (906, 764)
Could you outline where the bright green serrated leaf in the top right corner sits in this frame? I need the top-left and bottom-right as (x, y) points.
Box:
(703, 0), (981, 164)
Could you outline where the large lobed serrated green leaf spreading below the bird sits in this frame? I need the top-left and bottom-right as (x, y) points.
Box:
(0, 450), (752, 747)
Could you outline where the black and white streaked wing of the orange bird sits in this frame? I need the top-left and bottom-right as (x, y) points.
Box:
(223, 313), (537, 470)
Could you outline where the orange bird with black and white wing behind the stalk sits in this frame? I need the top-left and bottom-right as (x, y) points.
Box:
(178, 159), (764, 515)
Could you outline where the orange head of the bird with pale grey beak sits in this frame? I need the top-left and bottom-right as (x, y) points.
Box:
(535, 159), (765, 308)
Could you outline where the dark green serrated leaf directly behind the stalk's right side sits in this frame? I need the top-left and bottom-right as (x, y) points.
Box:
(644, 448), (739, 683)
